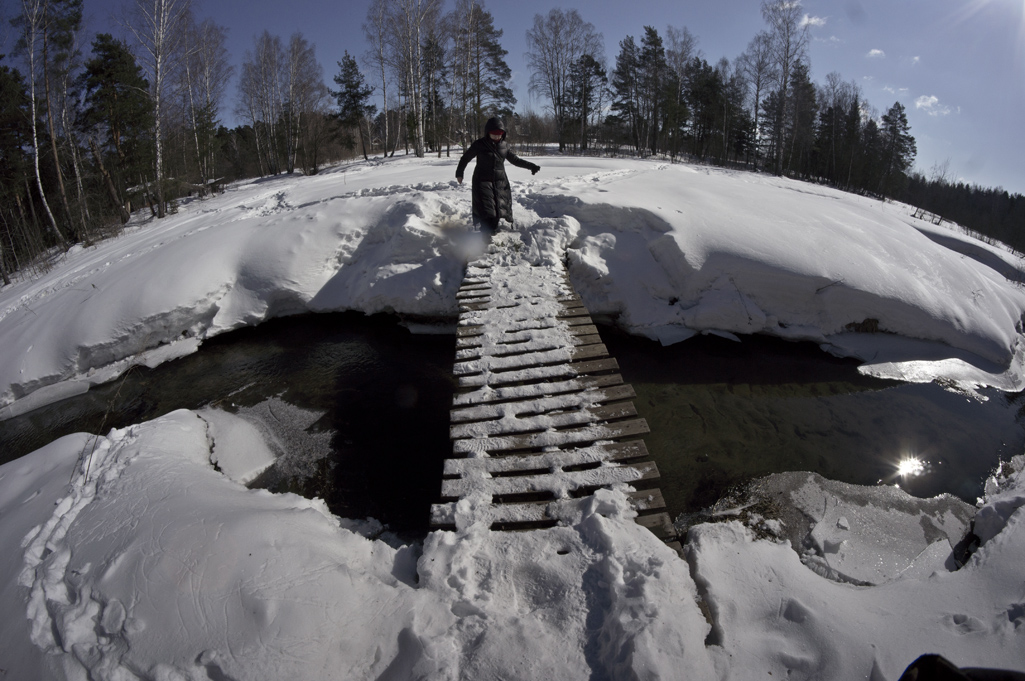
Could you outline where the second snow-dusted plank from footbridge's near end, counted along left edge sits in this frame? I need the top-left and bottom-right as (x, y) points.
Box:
(442, 462), (658, 499)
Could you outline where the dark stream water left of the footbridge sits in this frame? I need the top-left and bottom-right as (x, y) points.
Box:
(0, 313), (455, 531)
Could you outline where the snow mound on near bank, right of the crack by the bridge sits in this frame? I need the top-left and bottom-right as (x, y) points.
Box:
(687, 465), (1025, 681)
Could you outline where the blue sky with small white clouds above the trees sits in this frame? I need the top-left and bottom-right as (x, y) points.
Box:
(3, 0), (1025, 194)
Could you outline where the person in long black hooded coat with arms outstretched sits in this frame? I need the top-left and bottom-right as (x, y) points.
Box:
(455, 118), (541, 241)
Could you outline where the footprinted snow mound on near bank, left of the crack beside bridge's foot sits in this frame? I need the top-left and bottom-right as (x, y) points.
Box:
(0, 411), (711, 680)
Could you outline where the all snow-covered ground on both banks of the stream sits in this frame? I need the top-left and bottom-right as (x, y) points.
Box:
(6, 157), (1025, 681)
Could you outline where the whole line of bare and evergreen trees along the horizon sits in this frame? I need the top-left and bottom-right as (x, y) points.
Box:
(0, 0), (1025, 281)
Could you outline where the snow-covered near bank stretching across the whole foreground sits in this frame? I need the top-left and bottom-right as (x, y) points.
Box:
(0, 411), (1025, 681)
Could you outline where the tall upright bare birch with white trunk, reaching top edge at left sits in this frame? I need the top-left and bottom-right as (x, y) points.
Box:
(126, 0), (191, 217)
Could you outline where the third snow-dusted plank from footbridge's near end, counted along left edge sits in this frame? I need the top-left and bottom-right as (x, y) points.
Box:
(444, 440), (648, 477)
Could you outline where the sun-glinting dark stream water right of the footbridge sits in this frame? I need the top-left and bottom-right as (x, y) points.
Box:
(603, 329), (1025, 517)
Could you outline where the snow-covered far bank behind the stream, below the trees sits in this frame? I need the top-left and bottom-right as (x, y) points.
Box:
(6, 157), (1025, 418)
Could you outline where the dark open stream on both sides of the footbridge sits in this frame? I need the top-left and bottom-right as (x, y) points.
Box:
(0, 313), (1025, 535)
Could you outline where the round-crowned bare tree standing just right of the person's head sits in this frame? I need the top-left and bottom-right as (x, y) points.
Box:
(527, 9), (605, 151)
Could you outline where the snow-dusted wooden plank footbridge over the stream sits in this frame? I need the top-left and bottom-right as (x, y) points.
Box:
(432, 250), (679, 547)
